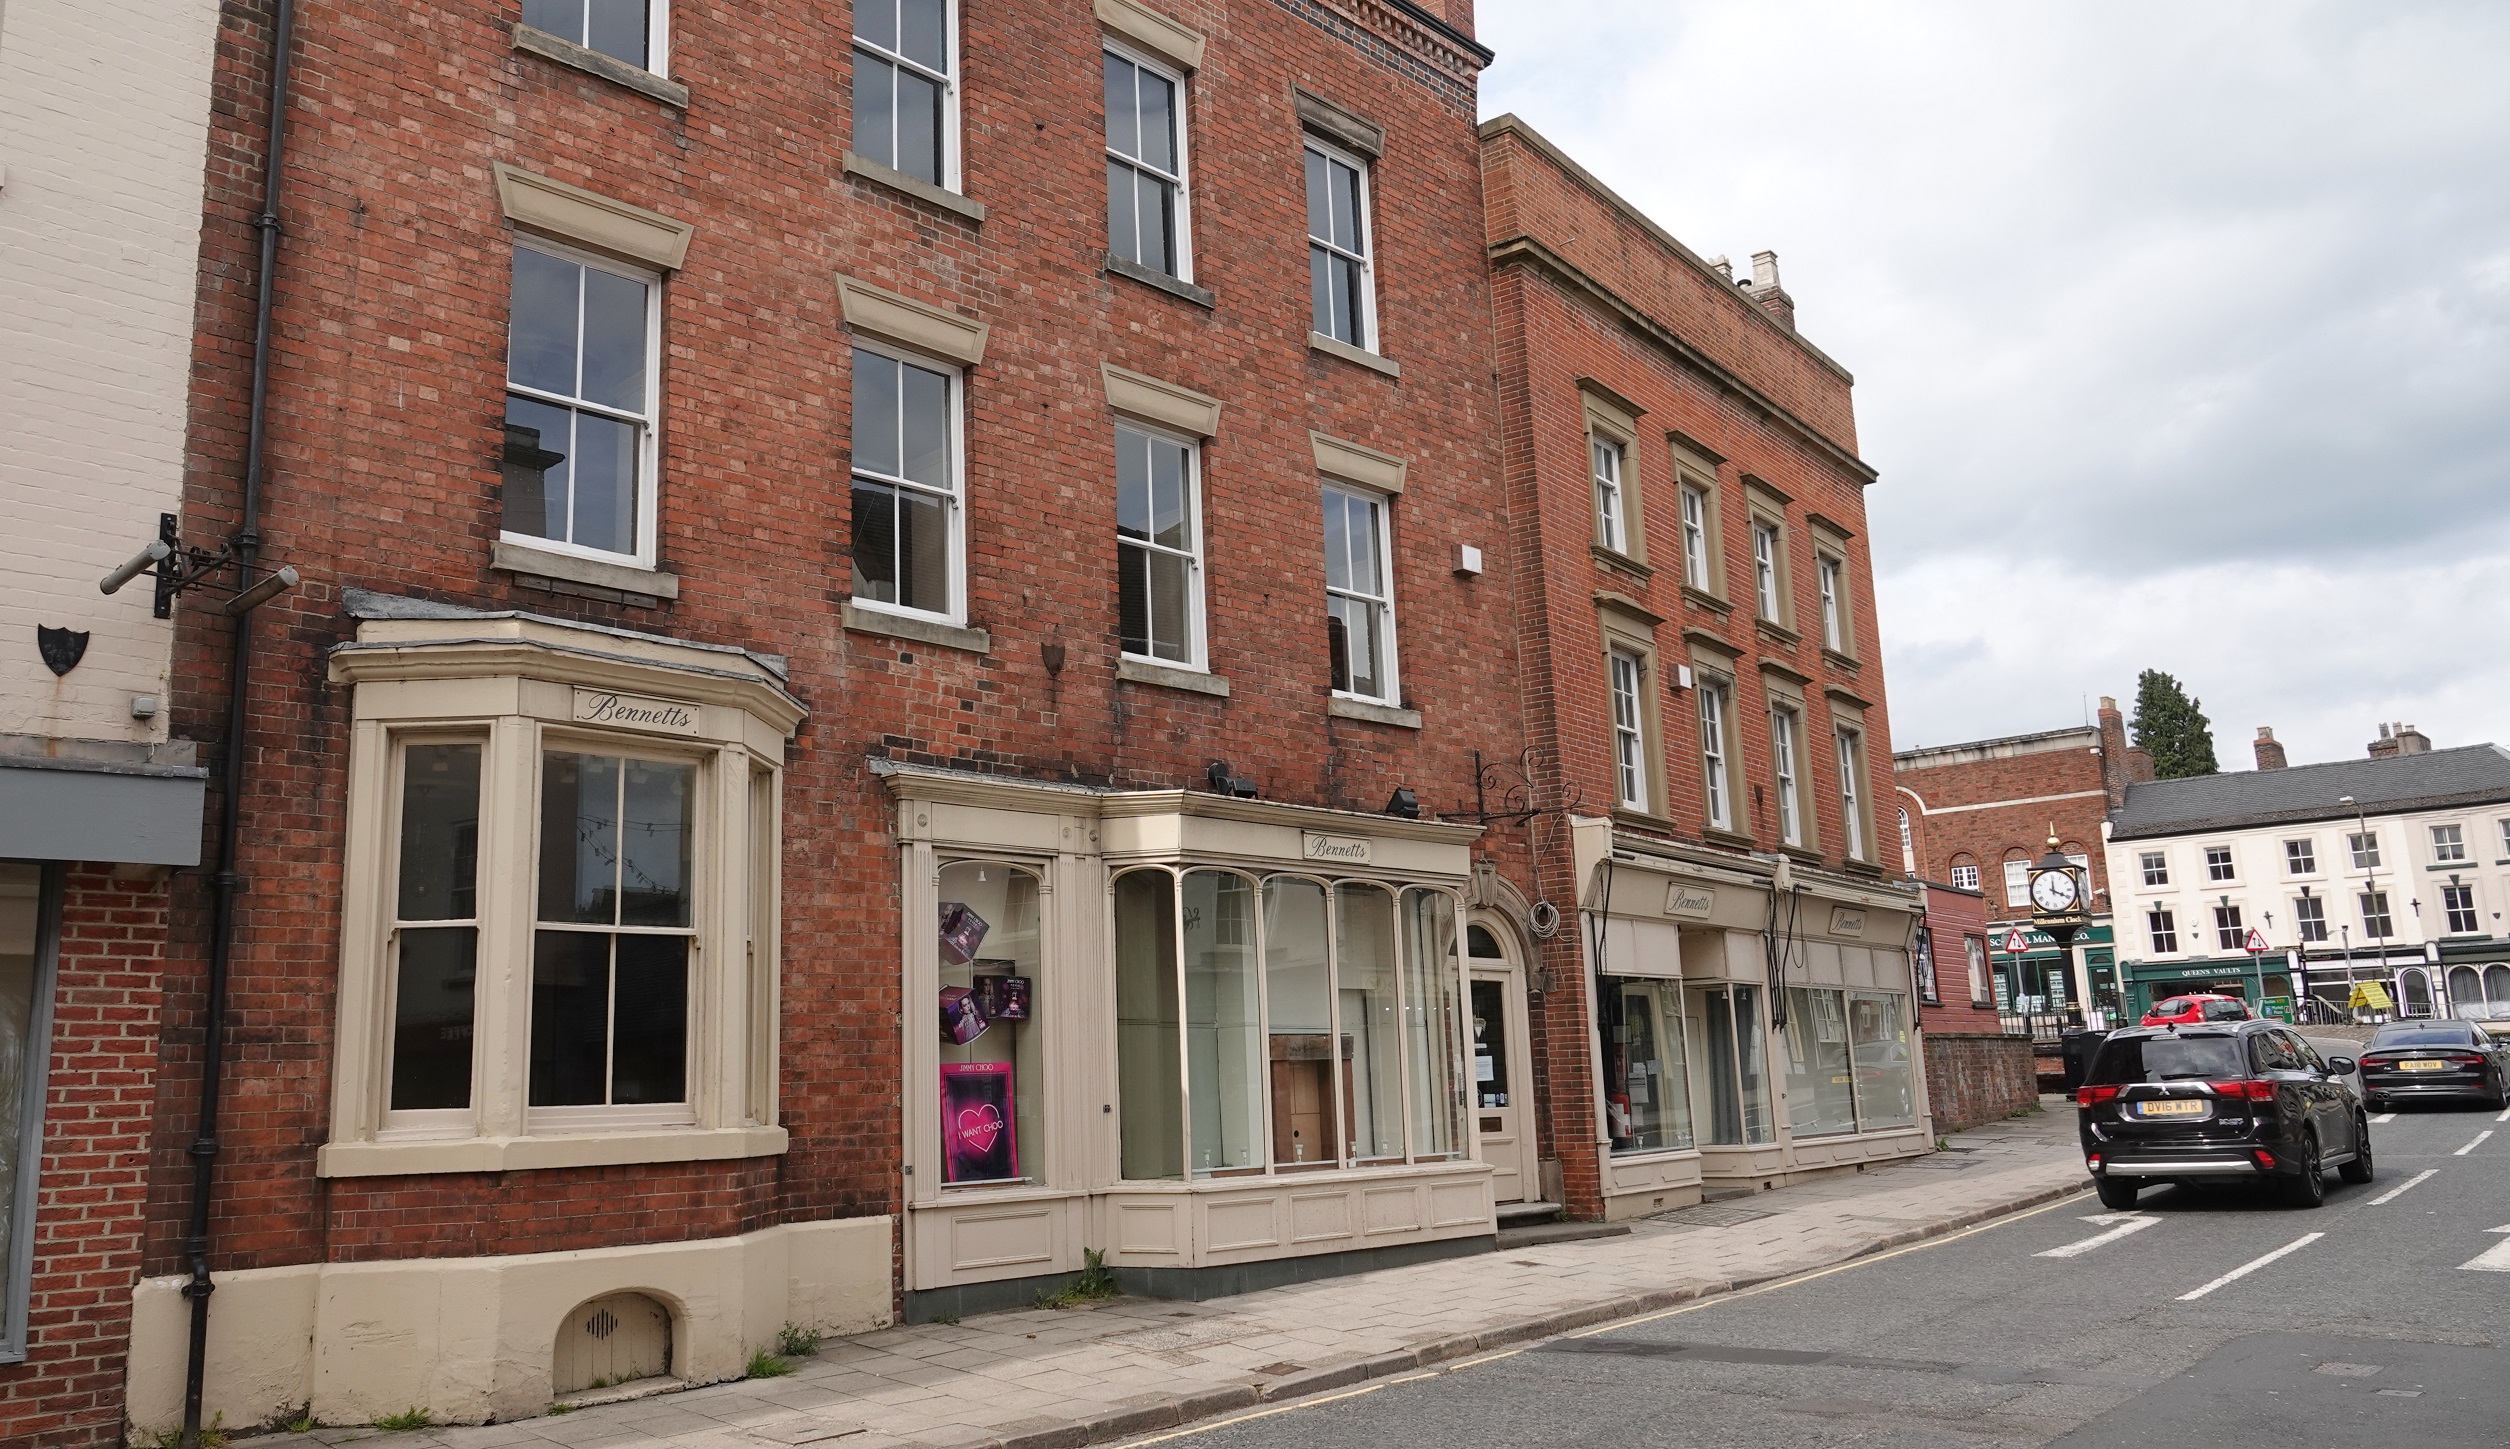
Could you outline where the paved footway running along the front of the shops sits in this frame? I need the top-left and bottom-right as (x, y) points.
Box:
(254, 1097), (2086, 1449)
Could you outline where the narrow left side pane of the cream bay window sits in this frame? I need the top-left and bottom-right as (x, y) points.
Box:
(384, 741), (479, 1128)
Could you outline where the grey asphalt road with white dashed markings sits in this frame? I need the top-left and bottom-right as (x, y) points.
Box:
(1137, 1107), (2510, 1449)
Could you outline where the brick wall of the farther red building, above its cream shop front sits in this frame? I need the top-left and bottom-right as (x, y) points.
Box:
(1483, 118), (1898, 1213)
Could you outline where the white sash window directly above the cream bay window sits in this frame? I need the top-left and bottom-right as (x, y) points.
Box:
(505, 244), (663, 558)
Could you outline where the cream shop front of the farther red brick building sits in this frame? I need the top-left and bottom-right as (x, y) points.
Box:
(1574, 819), (1933, 1218)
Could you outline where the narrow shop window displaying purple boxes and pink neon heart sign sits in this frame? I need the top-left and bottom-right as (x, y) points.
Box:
(939, 861), (1057, 1185)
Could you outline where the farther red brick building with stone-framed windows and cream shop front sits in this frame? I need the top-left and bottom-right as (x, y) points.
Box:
(1481, 116), (1933, 1215)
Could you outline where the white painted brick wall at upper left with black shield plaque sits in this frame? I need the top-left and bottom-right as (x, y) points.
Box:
(0, 0), (218, 741)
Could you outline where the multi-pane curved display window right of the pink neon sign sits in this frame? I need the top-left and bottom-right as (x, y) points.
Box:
(1114, 869), (1466, 1180)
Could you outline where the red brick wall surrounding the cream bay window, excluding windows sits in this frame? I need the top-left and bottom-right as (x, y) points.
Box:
(171, 0), (1526, 1325)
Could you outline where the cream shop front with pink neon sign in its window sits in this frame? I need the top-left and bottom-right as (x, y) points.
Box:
(871, 761), (1485, 1318)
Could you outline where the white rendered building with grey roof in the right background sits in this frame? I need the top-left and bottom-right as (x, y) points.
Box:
(2106, 726), (2510, 1017)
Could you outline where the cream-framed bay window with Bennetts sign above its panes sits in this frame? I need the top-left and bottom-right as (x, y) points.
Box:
(319, 615), (801, 1175)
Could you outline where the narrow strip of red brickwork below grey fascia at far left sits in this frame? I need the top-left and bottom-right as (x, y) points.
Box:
(0, 864), (168, 1449)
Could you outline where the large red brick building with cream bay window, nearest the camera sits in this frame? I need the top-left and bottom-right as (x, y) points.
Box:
(146, 0), (1536, 1429)
